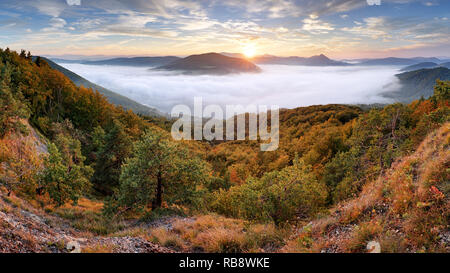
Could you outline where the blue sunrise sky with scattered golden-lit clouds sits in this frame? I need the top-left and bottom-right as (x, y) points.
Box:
(0, 0), (450, 59)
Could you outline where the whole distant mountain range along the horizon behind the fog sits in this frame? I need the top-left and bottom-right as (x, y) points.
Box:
(52, 52), (450, 71)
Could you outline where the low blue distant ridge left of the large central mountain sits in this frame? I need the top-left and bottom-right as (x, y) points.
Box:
(52, 56), (181, 67)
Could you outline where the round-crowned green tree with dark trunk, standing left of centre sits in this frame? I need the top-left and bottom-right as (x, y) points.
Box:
(118, 129), (208, 209)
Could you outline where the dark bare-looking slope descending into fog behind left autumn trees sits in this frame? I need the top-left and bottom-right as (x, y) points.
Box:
(38, 57), (166, 117)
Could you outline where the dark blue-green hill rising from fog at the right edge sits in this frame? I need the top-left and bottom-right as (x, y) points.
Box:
(384, 67), (450, 103)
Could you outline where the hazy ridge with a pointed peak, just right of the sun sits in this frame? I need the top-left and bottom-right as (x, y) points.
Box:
(252, 54), (351, 66)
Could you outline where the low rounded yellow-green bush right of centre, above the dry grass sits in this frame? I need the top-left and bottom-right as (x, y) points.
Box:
(212, 159), (327, 224)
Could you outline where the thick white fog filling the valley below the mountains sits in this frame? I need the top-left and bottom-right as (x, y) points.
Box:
(60, 63), (398, 113)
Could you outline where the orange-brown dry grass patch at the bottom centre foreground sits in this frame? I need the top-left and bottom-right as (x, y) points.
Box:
(151, 214), (287, 253)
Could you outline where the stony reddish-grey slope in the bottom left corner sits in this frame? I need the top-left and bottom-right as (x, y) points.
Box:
(0, 194), (172, 253)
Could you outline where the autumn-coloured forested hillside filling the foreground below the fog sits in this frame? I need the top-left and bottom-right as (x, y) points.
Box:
(0, 49), (450, 252)
